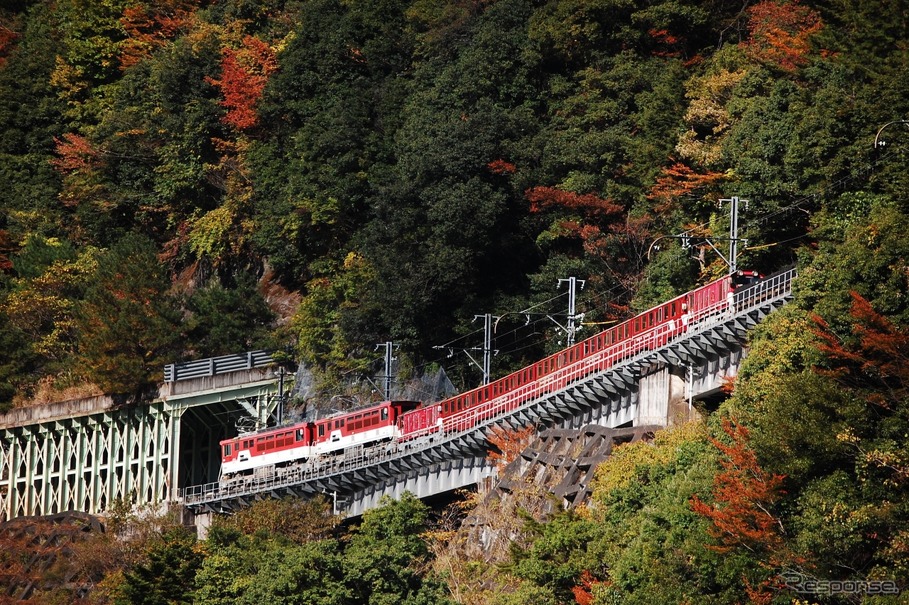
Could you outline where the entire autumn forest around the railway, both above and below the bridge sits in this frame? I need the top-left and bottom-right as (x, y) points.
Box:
(0, 0), (909, 605)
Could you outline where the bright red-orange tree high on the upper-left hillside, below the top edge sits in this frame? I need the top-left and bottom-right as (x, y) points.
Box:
(207, 36), (278, 130)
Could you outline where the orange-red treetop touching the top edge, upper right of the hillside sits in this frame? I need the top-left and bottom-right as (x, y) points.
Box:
(744, 0), (822, 71)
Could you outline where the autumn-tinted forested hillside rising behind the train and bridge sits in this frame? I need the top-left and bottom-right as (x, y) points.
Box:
(0, 0), (909, 405)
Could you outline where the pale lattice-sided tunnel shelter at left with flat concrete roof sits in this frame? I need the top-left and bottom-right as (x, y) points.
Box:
(0, 360), (277, 521)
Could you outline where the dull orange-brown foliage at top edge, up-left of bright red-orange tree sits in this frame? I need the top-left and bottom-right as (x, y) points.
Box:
(120, 0), (197, 69)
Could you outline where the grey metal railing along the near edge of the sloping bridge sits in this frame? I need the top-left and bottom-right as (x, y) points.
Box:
(180, 268), (796, 506)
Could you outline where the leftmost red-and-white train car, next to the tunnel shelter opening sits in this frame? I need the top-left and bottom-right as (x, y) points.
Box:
(221, 422), (312, 478)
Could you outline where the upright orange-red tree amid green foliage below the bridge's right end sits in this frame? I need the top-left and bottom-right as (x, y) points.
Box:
(690, 419), (784, 552)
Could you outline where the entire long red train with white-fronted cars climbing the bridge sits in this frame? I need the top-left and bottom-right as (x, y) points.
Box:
(221, 271), (763, 478)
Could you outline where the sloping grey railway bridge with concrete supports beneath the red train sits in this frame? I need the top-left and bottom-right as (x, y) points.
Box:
(181, 269), (795, 516)
